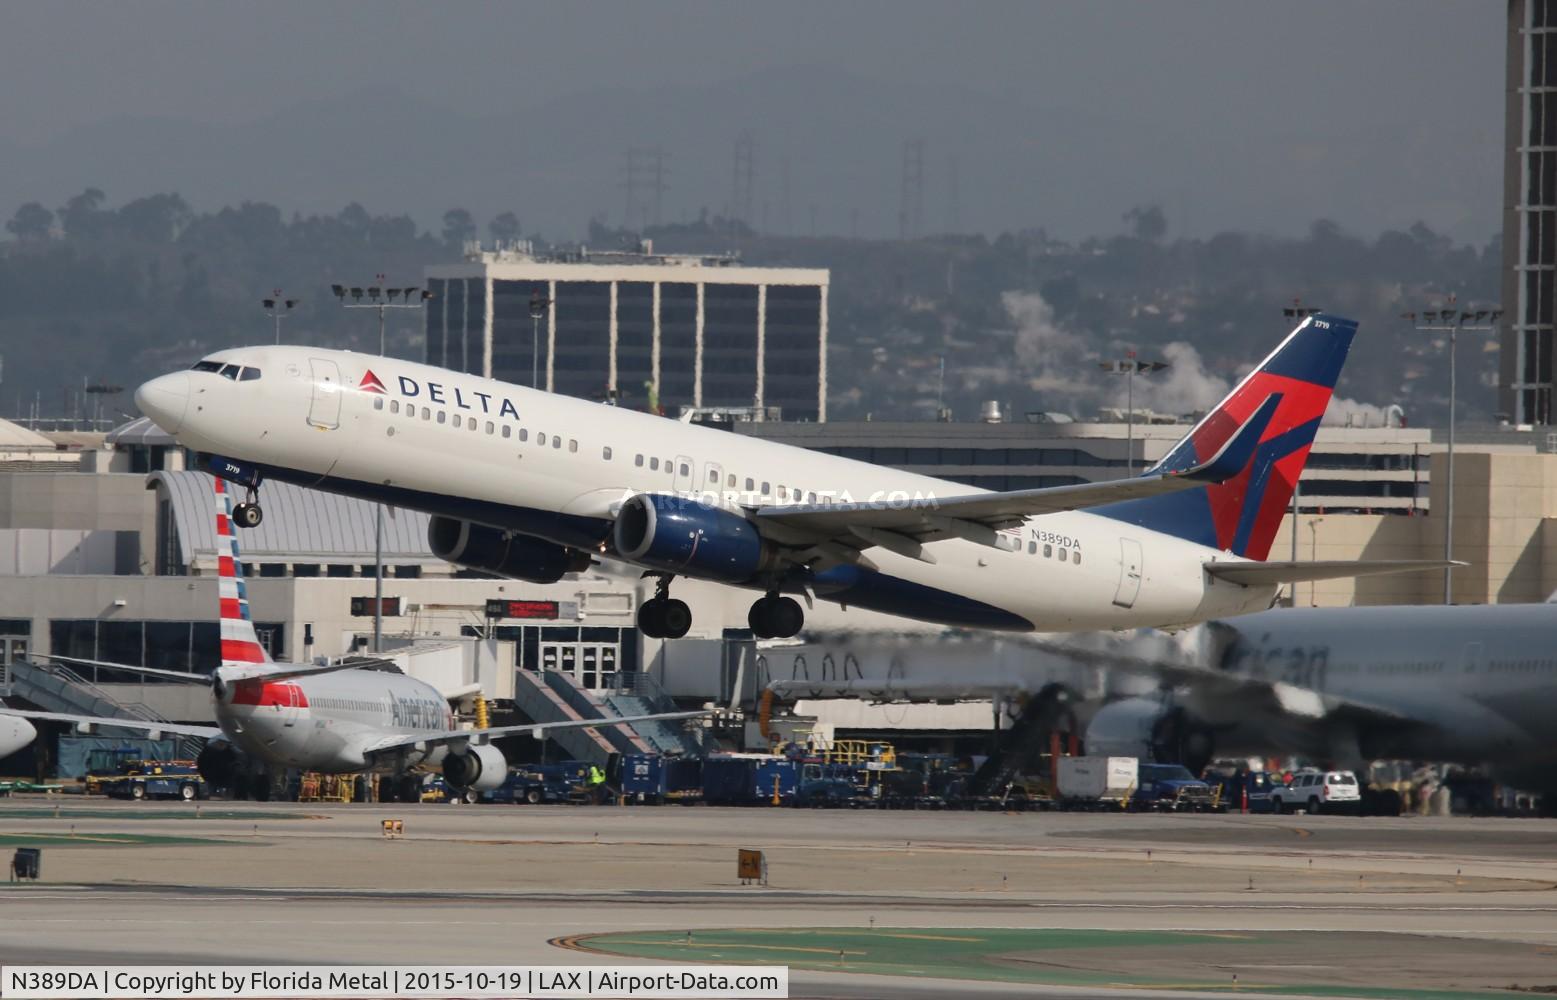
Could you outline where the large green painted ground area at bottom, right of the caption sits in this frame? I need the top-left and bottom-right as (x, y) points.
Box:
(578, 927), (1507, 1000)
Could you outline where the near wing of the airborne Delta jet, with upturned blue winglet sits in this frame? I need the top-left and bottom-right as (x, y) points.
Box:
(752, 396), (1281, 562)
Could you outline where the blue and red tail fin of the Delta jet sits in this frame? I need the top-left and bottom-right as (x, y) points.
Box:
(1091, 313), (1358, 559)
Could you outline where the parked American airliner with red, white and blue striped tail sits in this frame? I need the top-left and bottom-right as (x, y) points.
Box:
(0, 478), (707, 801)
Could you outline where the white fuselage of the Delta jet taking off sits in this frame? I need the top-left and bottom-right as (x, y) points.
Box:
(137, 347), (1275, 631)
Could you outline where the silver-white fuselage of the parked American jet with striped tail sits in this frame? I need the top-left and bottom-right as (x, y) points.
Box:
(216, 670), (455, 774)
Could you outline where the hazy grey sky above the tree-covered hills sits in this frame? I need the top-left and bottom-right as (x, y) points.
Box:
(0, 0), (1504, 241)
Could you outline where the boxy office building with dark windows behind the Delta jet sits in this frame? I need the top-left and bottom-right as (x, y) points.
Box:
(425, 245), (828, 421)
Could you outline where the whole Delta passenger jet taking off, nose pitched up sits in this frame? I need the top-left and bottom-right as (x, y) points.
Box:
(135, 315), (1443, 639)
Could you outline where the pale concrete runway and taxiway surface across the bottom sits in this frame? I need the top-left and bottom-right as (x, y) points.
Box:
(0, 799), (1557, 997)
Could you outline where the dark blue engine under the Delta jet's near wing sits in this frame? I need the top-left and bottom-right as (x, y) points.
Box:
(612, 494), (772, 583)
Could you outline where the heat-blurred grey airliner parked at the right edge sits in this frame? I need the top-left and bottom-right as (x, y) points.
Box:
(1064, 604), (1557, 793)
